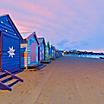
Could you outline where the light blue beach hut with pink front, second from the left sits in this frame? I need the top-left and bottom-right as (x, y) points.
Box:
(21, 32), (40, 68)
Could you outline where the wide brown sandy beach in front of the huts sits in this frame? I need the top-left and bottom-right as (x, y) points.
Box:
(0, 56), (104, 104)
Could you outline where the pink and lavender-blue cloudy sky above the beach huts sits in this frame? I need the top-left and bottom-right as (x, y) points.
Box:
(0, 0), (104, 51)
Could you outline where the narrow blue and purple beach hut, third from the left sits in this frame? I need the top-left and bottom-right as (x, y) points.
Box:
(38, 38), (45, 62)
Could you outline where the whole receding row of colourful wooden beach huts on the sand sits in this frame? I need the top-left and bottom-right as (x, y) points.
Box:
(0, 15), (62, 90)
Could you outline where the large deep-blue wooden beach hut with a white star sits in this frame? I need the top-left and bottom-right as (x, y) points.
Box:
(0, 15), (23, 72)
